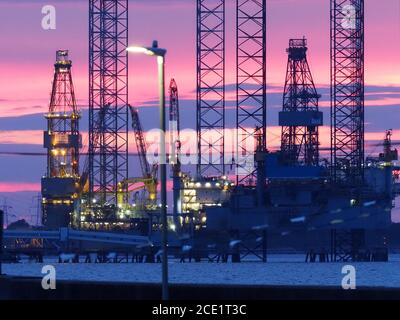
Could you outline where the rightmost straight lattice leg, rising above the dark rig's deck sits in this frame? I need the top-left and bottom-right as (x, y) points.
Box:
(331, 0), (364, 187)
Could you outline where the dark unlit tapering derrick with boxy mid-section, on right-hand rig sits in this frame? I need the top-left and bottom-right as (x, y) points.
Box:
(279, 38), (323, 166)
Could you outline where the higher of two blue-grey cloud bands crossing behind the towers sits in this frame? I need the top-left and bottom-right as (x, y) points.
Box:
(0, 84), (400, 136)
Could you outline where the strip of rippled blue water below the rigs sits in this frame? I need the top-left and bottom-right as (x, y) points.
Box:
(3, 255), (400, 288)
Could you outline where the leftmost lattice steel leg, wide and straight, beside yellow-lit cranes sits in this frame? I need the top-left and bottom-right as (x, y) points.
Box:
(89, 0), (129, 214)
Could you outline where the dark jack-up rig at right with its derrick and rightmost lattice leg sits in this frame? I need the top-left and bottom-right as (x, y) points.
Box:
(206, 21), (398, 261)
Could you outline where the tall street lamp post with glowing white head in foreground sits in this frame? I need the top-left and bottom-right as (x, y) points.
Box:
(126, 41), (168, 300)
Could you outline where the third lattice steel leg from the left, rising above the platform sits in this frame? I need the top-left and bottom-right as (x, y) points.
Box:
(236, 0), (266, 185)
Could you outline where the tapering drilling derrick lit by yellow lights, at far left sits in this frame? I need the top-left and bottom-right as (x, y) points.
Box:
(42, 50), (81, 228)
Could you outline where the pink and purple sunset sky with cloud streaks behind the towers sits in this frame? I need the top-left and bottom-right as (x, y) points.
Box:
(0, 0), (400, 224)
